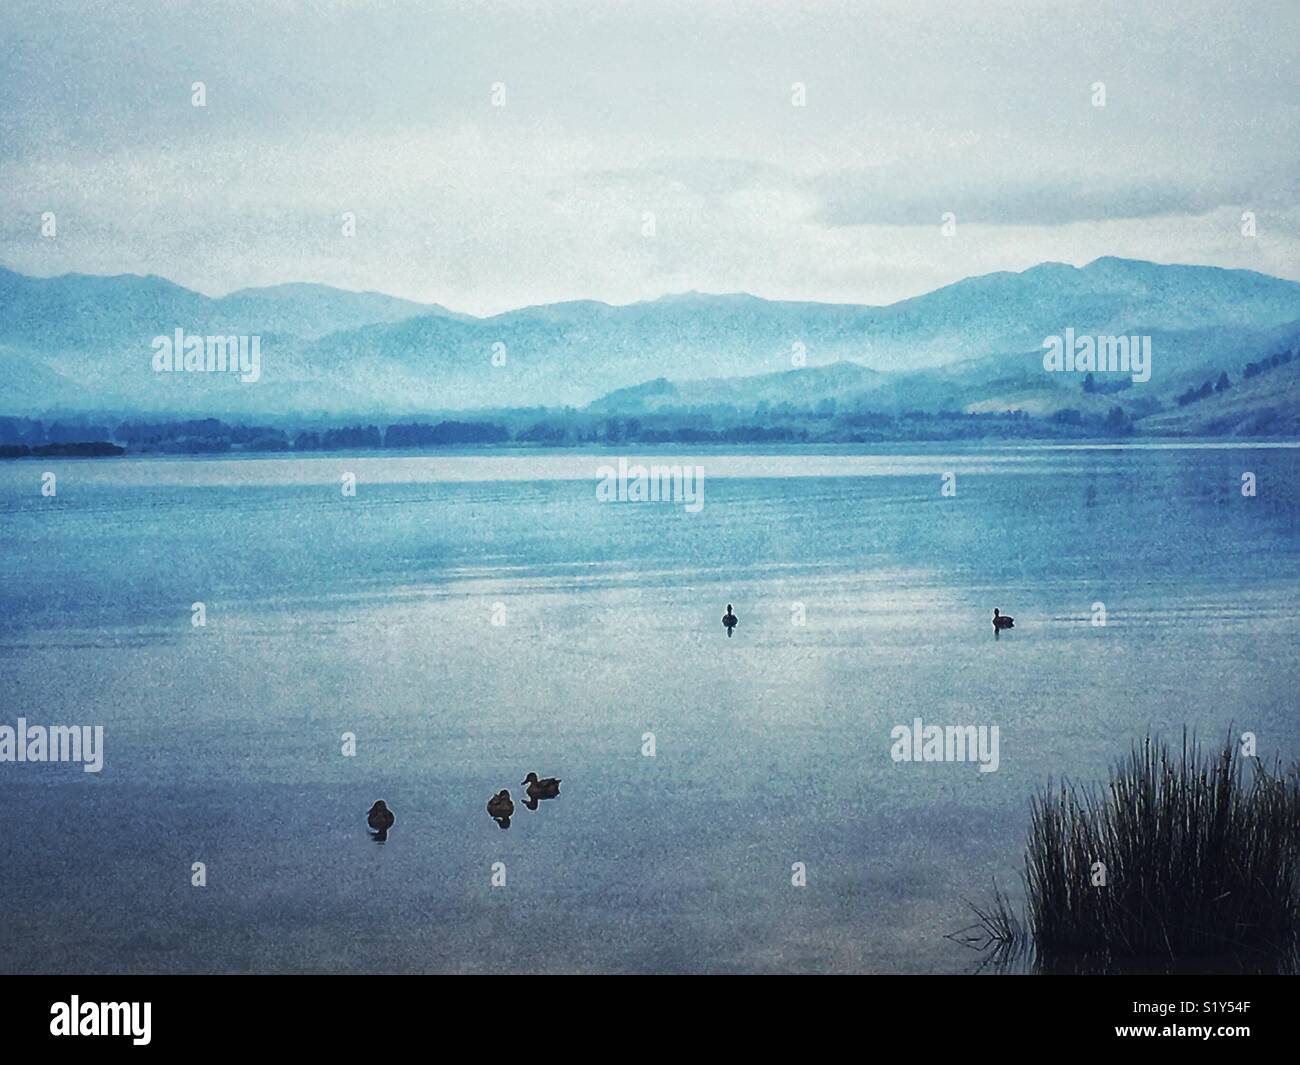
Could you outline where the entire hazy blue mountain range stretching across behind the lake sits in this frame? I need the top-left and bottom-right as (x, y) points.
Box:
(0, 257), (1300, 429)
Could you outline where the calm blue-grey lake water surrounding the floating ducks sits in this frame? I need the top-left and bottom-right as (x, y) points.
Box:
(0, 447), (1300, 971)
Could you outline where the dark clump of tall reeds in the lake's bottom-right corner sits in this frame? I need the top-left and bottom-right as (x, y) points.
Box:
(1024, 736), (1300, 964)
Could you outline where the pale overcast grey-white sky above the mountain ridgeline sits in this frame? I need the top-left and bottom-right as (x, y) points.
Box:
(0, 0), (1300, 313)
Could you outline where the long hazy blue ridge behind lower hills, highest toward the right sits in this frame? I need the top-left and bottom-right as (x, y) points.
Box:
(287, 259), (1300, 408)
